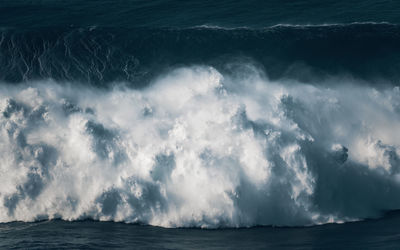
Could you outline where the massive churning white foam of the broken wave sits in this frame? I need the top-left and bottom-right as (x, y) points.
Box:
(0, 64), (400, 228)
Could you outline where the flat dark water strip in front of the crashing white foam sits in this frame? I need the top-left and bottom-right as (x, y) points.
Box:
(0, 212), (400, 249)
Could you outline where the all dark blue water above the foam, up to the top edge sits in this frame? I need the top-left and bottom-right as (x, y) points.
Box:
(0, 0), (400, 86)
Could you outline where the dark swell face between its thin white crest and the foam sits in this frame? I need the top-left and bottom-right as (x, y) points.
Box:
(0, 23), (400, 87)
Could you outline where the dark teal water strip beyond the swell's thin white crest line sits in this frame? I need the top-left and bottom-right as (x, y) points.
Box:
(0, 0), (400, 28)
